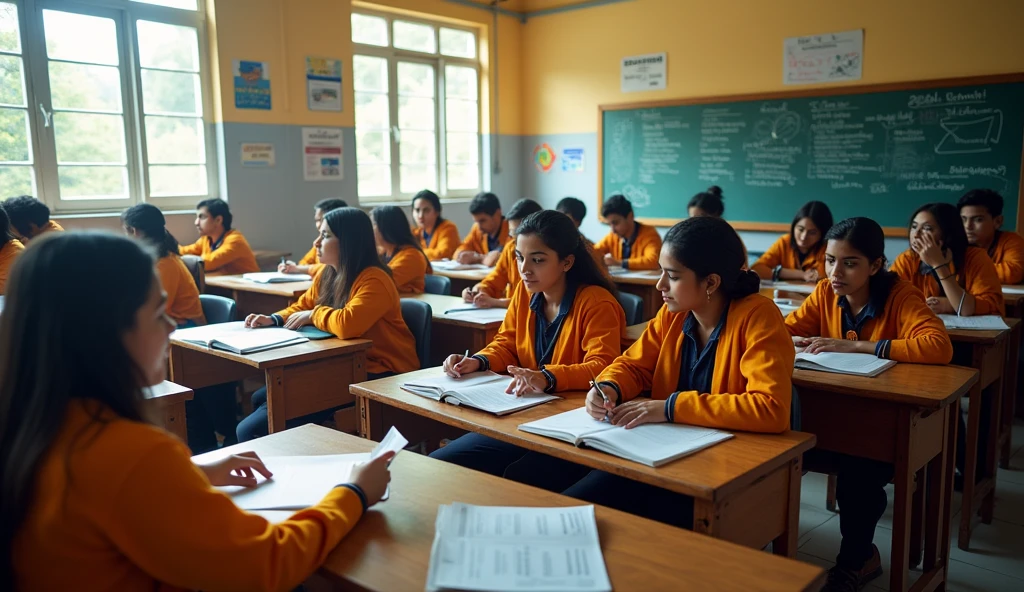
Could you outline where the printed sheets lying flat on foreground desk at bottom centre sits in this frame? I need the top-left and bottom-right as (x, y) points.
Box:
(427, 503), (611, 592)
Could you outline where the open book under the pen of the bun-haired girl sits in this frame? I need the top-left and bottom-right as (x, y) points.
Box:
(519, 407), (732, 467)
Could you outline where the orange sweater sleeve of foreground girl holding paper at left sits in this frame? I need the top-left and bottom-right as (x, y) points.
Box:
(107, 438), (362, 590)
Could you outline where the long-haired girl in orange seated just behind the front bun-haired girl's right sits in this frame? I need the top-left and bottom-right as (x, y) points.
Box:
(752, 202), (833, 282)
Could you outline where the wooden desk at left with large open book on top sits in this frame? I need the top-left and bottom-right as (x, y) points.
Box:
(171, 338), (372, 433)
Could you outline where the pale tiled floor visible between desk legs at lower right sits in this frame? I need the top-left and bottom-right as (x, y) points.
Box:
(798, 420), (1024, 592)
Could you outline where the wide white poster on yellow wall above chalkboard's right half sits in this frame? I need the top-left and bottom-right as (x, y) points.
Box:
(782, 29), (864, 84)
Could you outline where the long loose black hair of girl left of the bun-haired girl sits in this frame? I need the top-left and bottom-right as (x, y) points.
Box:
(515, 210), (618, 295)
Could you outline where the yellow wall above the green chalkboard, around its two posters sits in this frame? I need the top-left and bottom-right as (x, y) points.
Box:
(521, 0), (1024, 135)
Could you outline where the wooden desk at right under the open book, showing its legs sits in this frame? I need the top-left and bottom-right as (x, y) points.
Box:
(793, 364), (979, 591)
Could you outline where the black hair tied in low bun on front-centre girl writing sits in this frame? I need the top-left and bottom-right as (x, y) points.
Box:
(665, 216), (761, 298)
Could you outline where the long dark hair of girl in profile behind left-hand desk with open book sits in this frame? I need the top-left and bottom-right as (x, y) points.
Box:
(316, 208), (391, 308)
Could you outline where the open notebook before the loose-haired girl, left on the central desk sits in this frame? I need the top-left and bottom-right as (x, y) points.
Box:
(401, 372), (558, 415)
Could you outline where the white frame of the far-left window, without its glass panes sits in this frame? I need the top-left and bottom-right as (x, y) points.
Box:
(7, 0), (219, 215)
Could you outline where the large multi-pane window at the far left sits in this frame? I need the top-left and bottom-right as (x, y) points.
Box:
(0, 0), (216, 213)
